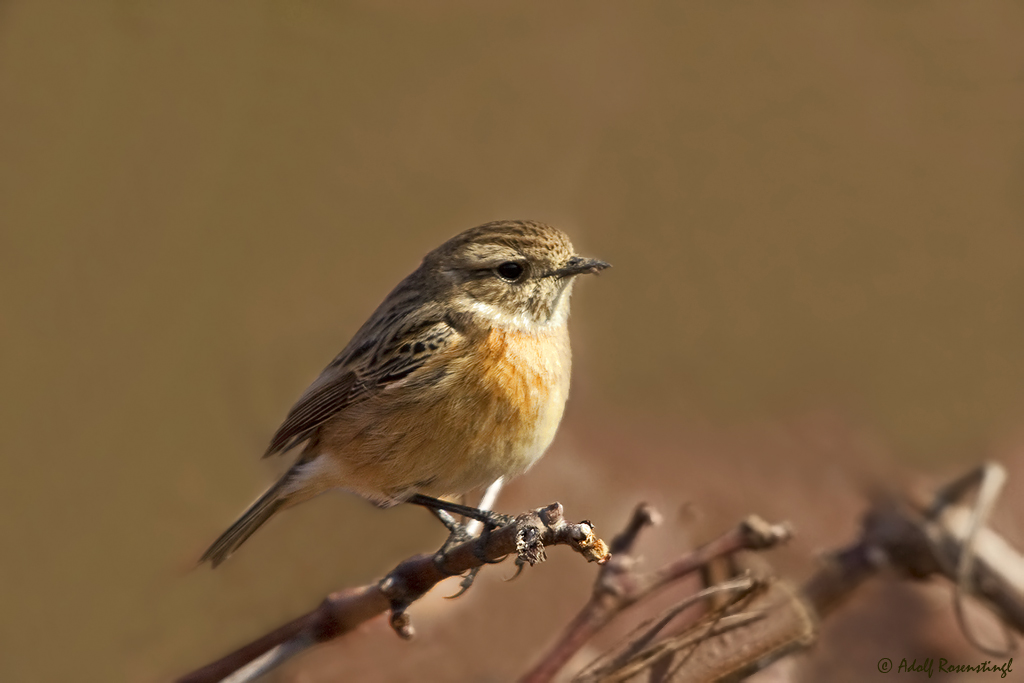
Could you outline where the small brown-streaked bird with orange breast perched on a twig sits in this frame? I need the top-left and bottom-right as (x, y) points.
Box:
(200, 220), (609, 567)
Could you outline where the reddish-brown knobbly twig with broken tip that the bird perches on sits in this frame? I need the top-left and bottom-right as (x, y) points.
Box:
(177, 503), (609, 683)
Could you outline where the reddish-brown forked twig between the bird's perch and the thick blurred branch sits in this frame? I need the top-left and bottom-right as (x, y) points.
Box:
(520, 504), (791, 683)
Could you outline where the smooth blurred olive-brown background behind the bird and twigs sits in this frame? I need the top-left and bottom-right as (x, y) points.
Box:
(0, 0), (1024, 683)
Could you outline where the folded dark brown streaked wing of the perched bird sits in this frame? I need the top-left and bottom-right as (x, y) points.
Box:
(263, 319), (461, 458)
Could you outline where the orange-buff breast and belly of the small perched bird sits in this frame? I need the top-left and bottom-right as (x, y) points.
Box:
(315, 326), (571, 501)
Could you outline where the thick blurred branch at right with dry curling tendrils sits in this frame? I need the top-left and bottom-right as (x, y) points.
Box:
(552, 464), (1024, 683)
